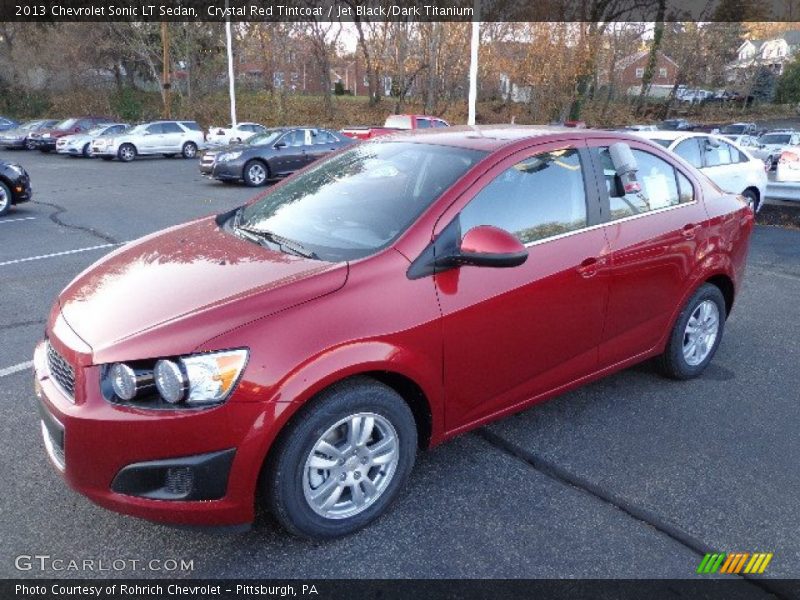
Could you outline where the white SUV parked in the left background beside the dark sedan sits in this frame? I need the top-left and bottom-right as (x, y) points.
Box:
(91, 121), (205, 162)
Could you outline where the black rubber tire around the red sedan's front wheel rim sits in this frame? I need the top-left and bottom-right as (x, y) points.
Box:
(268, 377), (417, 539)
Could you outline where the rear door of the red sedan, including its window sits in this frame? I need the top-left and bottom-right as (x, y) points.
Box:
(590, 140), (708, 368)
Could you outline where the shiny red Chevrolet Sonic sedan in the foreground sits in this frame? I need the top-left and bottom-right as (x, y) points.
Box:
(34, 127), (753, 538)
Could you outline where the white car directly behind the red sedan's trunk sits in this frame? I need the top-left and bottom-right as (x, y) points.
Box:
(638, 131), (767, 212)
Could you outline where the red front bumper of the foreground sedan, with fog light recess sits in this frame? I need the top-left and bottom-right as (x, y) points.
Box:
(33, 339), (268, 526)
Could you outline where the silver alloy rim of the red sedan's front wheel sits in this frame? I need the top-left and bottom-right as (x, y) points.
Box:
(303, 413), (400, 519)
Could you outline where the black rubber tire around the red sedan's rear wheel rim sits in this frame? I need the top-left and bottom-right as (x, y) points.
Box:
(656, 283), (727, 380)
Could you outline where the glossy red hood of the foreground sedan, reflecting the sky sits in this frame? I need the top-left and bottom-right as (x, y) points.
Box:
(59, 217), (347, 363)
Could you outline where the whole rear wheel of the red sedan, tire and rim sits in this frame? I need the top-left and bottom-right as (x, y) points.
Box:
(658, 283), (726, 379)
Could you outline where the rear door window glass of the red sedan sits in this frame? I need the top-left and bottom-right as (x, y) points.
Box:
(600, 148), (694, 221)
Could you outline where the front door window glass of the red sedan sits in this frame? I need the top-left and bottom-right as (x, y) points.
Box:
(460, 148), (588, 244)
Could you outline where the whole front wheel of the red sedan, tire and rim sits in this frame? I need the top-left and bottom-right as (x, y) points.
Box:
(263, 378), (417, 539)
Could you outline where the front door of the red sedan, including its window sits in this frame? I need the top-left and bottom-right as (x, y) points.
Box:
(434, 142), (608, 430)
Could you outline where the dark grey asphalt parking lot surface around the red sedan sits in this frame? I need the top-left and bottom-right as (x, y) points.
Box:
(0, 151), (800, 591)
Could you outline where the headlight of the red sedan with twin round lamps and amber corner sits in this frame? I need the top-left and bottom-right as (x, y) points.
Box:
(101, 350), (248, 408)
